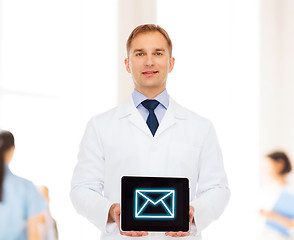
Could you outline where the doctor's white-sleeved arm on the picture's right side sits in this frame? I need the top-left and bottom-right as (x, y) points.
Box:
(191, 123), (230, 232)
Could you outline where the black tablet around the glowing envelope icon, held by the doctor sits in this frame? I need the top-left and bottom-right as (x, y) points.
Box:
(121, 176), (189, 232)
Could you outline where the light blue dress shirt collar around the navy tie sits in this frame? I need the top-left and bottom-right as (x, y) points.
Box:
(132, 89), (169, 124)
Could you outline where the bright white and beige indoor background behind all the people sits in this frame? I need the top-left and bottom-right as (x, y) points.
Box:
(0, 0), (294, 240)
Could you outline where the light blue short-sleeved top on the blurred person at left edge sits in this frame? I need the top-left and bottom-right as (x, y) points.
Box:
(0, 166), (47, 240)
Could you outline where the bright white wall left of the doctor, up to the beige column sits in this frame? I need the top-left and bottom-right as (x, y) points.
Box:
(0, 0), (118, 240)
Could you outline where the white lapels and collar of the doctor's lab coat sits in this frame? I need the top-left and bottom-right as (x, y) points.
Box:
(118, 96), (187, 139)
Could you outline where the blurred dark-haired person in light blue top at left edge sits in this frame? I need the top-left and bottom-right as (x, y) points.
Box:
(0, 131), (46, 240)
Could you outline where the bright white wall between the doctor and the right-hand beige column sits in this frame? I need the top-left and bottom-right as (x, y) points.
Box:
(157, 0), (259, 240)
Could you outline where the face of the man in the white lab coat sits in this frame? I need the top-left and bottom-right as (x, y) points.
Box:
(125, 31), (175, 93)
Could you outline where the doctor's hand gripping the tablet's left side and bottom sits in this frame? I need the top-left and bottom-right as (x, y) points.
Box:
(108, 203), (148, 237)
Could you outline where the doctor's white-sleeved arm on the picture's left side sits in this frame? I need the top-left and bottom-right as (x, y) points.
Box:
(70, 118), (112, 231)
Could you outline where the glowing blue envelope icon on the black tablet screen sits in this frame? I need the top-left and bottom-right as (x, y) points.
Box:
(135, 189), (175, 219)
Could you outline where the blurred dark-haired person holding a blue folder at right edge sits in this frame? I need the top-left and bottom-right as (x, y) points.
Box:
(260, 151), (294, 240)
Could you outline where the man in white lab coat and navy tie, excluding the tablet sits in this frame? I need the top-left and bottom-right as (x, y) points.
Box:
(71, 24), (230, 239)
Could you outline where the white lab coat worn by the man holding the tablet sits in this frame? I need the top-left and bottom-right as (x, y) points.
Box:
(71, 94), (230, 240)
